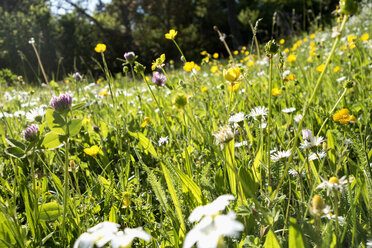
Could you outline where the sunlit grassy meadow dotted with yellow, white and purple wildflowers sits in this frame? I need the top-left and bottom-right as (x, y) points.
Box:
(0, 0), (372, 248)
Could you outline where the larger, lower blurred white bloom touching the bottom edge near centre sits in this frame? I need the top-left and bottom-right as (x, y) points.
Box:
(183, 211), (244, 248)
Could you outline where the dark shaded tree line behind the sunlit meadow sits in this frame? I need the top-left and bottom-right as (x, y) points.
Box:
(0, 0), (338, 82)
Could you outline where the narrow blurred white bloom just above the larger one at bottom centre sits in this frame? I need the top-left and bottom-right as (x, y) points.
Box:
(189, 195), (235, 222)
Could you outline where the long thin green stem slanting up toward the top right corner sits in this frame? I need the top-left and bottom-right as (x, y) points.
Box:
(271, 15), (349, 202)
